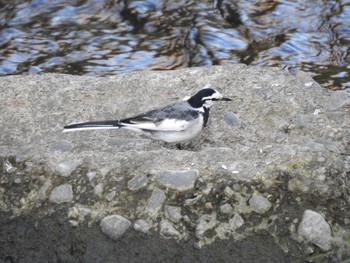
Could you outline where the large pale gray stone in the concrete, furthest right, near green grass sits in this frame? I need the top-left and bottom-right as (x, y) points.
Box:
(298, 210), (332, 251)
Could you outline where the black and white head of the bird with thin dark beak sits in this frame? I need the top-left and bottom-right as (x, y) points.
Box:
(188, 88), (231, 109)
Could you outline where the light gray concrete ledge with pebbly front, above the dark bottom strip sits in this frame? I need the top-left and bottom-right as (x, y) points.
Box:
(0, 65), (350, 260)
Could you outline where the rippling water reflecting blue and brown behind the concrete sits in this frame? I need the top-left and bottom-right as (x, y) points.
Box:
(0, 0), (350, 89)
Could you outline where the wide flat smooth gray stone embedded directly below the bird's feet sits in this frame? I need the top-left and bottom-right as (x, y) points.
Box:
(157, 169), (199, 191)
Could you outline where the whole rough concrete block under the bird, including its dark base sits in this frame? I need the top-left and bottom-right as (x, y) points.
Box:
(0, 65), (350, 262)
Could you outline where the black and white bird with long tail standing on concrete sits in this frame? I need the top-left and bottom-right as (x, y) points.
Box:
(64, 88), (231, 143)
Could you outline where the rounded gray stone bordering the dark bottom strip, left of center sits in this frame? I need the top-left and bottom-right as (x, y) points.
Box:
(100, 215), (131, 240)
